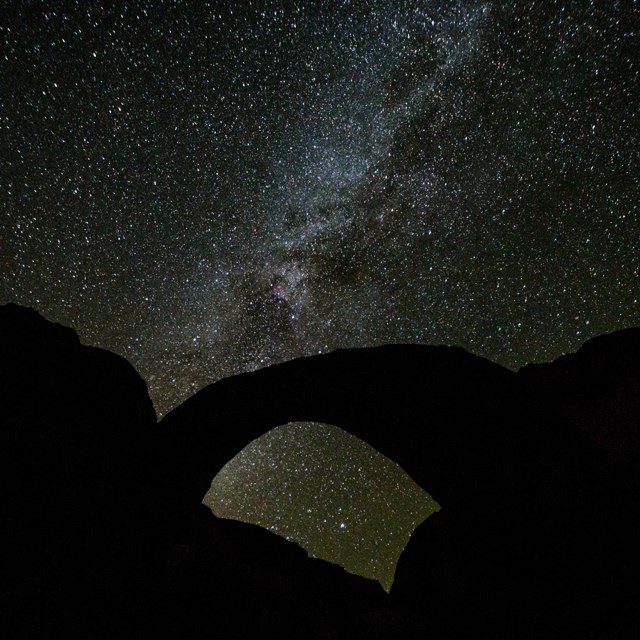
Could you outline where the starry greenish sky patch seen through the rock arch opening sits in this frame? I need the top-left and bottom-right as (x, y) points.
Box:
(203, 422), (440, 591)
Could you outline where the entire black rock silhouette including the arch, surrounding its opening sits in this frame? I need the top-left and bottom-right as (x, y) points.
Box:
(0, 305), (640, 638)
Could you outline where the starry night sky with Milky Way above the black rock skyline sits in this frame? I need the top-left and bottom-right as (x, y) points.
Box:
(0, 0), (640, 584)
